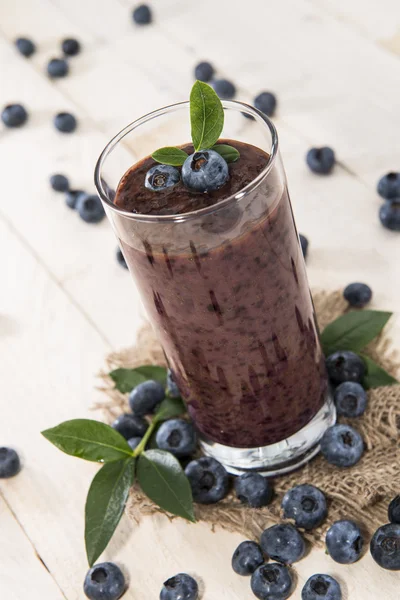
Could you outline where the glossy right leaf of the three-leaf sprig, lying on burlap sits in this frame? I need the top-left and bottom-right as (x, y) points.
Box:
(137, 450), (196, 523)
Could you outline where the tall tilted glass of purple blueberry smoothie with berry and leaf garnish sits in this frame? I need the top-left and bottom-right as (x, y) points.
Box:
(95, 82), (335, 475)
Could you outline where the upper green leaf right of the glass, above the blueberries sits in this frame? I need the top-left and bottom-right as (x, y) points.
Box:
(321, 310), (392, 355)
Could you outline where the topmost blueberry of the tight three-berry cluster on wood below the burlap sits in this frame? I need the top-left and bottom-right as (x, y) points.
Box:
(261, 523), (306, 565)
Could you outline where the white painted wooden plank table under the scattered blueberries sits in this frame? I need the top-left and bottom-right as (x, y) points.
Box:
(0, 0), (400, 600)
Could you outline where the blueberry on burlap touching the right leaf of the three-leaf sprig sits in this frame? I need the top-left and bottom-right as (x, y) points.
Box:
(185, 456), (229, 504)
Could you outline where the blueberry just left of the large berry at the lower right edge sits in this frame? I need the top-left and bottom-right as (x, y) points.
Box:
(325, 519), (364, 565)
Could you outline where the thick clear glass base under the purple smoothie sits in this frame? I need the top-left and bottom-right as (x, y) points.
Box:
(200, 393), (336, 477)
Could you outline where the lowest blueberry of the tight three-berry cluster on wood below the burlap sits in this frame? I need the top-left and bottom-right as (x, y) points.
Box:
(251, 563), (293, 600)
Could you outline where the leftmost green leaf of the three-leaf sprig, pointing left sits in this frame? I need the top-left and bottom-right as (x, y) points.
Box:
(42, 419), (133, 462)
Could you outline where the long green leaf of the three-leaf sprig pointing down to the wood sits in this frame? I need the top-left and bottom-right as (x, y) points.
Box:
(85, 458), (135, 566)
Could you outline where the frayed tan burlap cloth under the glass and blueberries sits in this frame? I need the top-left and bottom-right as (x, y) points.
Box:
(97, 292), (400, 544)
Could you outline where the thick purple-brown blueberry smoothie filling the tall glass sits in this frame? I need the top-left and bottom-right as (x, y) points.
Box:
(115, 140), (327, 448)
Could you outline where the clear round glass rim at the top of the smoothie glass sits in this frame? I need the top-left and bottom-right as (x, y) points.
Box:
(94, 100), (278, 223)
